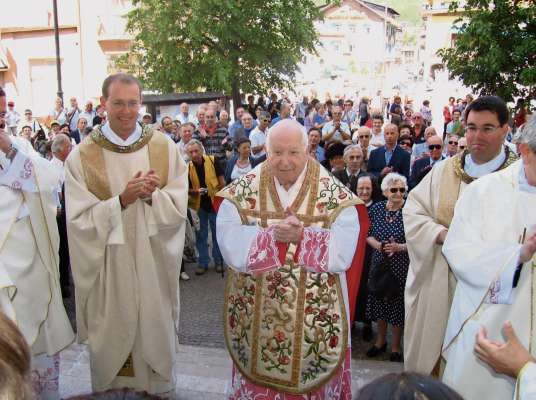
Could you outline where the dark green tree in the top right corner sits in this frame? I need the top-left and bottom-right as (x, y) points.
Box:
(438, 0), (536, 101)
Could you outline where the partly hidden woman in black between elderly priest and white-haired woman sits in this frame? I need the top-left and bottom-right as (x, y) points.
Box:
(355, 174), (379, 342)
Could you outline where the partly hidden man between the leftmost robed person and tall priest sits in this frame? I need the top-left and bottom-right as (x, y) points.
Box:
(51, 134), (73, 298)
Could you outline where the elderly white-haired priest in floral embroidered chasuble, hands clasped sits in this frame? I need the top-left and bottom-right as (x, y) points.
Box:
(216, 120), (368, 399)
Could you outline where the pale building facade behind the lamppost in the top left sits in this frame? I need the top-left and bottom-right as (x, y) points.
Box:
(0, 0), (132, 116)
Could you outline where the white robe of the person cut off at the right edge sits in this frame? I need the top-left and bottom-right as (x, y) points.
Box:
(443, 161), (536, 399)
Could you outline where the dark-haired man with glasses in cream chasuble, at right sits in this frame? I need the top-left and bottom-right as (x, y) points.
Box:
(403, 96), (518, 376)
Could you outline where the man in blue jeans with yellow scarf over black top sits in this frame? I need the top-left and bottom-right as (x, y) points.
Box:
(186, 139), (225, 275)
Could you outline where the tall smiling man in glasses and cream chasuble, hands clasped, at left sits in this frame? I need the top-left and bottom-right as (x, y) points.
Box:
(65, 74), (187, 393)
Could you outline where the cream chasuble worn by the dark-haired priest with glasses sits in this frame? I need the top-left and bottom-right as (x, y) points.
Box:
(402, 147), (517, 376)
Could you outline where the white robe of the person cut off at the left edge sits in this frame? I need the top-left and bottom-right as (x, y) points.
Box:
(0, 138), (74, 399)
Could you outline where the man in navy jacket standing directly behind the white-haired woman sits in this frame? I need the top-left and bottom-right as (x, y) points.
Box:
(367, 124), (410, 180)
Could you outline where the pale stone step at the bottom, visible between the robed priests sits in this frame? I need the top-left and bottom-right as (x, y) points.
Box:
(60, 344), (402, 400)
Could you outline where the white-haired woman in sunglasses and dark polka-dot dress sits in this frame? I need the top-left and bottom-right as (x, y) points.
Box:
(366, 173), (409, 362)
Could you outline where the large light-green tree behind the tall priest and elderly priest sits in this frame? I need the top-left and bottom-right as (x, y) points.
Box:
(122, 0), (322, 111)
